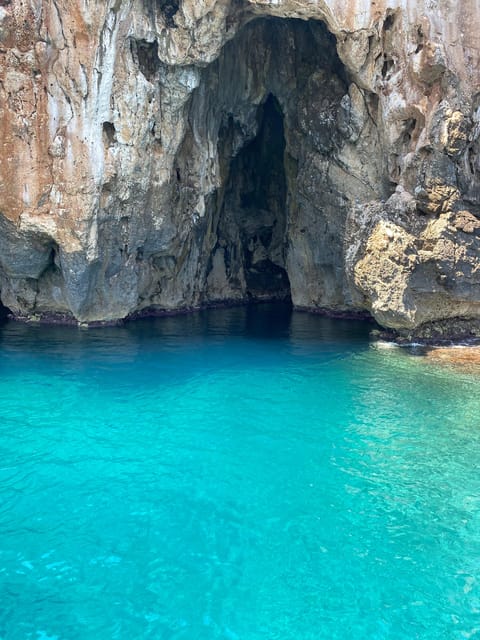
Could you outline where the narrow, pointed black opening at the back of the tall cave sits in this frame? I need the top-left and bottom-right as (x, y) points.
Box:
(219, 93), (290, 300)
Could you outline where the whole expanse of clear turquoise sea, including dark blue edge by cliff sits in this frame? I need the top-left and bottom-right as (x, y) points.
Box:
(0, 305), (480, 640)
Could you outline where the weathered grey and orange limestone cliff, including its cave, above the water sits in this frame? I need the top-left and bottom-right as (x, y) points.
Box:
(0, 0), (480, 335)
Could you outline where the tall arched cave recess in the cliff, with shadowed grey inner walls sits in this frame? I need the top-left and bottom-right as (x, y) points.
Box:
(171, 17), (381, 310)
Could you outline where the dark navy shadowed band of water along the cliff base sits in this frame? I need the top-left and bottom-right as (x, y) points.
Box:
(0, 302), (372, 360)
